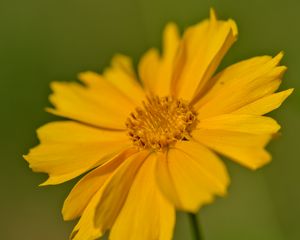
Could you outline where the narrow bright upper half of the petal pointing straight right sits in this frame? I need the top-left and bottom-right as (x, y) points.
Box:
(197, 114), (280, 134)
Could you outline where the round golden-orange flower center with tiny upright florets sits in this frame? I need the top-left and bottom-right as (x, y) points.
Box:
(126, 96), (198, 150)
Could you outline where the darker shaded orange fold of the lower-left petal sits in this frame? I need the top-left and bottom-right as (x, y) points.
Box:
(94, 151), (149, 232)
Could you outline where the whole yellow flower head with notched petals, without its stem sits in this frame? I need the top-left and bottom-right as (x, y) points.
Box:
(25, 11), (292, 240)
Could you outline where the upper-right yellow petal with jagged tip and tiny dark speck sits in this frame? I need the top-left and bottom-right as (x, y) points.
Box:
(195, 53), (286, 118)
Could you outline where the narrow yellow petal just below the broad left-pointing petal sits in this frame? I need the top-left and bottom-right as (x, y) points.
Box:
(62, 148), (136, 220)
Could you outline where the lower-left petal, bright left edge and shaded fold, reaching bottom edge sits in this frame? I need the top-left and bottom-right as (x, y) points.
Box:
(71, 151), (149, 240)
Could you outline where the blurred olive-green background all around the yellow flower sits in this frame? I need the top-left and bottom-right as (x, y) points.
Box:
(0, 0), (300, 240)
